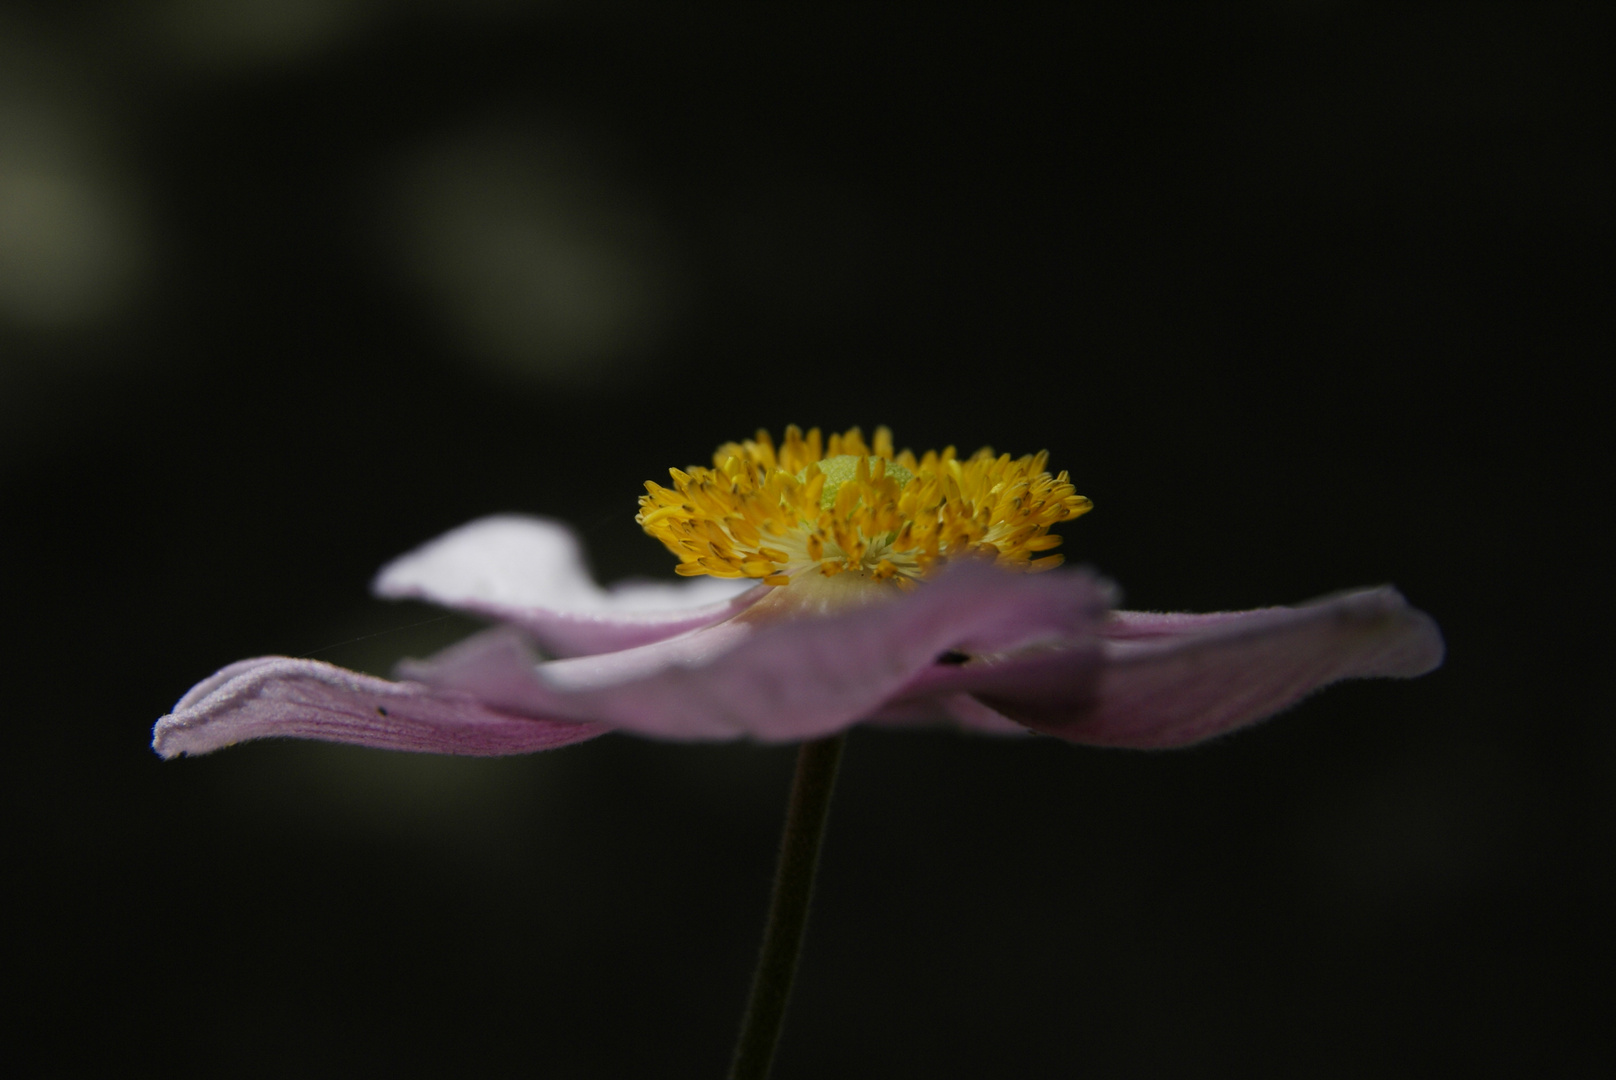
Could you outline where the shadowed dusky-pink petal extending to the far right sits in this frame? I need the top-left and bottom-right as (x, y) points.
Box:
(963, 587), (1443, 749)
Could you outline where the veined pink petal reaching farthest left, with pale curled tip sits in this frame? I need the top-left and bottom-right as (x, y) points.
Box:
(152, 656), (608, 758)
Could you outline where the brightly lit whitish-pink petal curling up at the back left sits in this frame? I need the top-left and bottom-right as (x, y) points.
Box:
(372, 514), (768, 656)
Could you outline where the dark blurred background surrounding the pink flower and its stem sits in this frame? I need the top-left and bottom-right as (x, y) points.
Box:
(0, 0), (1616, 1080)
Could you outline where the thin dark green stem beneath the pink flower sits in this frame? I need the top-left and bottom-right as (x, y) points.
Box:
(729, 732), (847, 1080)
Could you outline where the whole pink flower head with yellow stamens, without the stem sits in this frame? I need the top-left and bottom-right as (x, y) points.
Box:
(154, 428), (1443, 757)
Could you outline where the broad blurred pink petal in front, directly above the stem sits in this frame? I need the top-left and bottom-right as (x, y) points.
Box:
(402, 563), (1110, 740)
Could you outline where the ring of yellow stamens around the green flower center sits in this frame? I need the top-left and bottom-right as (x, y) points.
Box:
(635, 425), (1092, 585)
